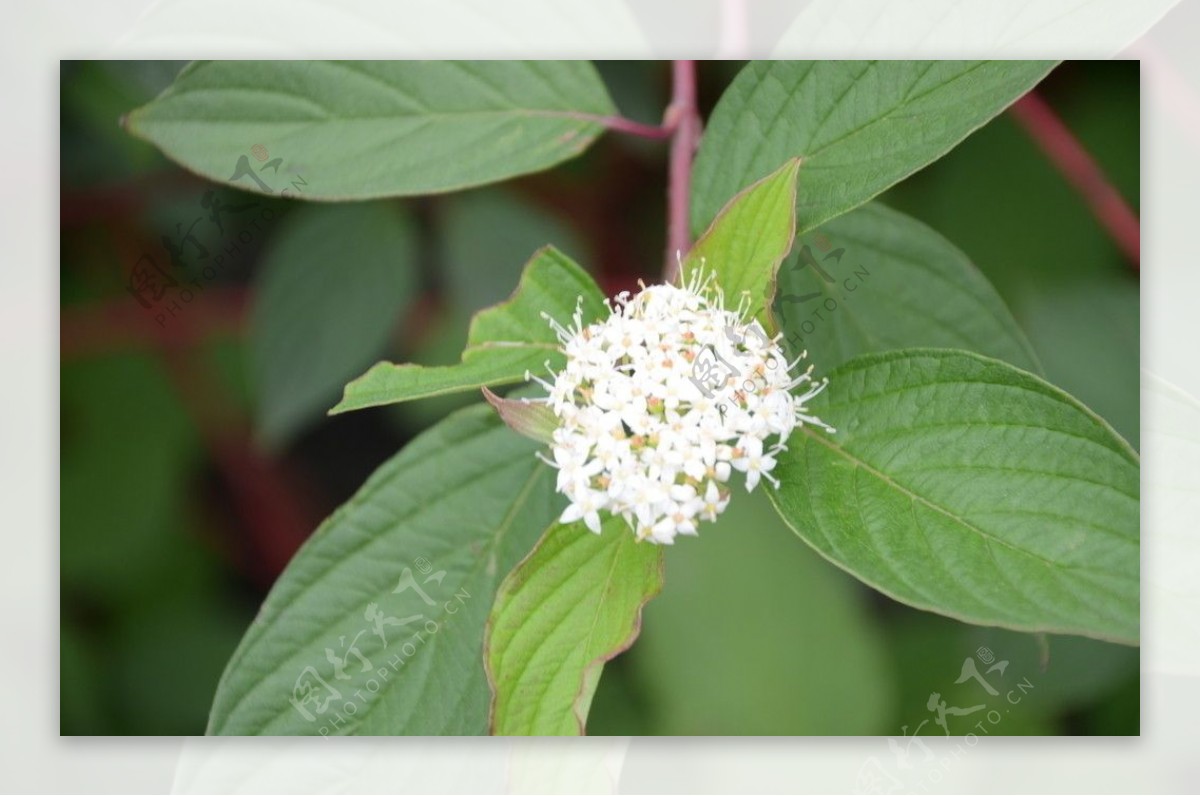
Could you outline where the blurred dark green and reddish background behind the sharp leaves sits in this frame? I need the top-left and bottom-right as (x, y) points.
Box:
(60, 61), (1139, 735)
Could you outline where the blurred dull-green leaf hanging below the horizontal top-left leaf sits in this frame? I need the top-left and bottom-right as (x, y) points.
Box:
(250, 203), (415, 444)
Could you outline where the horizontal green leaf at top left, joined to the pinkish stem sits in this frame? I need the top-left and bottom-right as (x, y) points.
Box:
(126, 61), (613, 199)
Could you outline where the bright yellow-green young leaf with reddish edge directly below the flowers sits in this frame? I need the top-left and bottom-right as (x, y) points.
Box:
(485, 516), (662, 735)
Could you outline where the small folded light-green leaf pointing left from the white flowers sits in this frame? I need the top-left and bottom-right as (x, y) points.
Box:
(330, 246), (606, 414)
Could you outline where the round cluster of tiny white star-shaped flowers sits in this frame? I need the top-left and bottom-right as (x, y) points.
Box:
(536, 273), (832, 544)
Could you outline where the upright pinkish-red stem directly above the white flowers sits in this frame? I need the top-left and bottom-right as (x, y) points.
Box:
(662, 61), (700, 282)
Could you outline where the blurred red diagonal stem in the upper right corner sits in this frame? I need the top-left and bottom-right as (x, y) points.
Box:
(1012, 91), (1141, 270)
